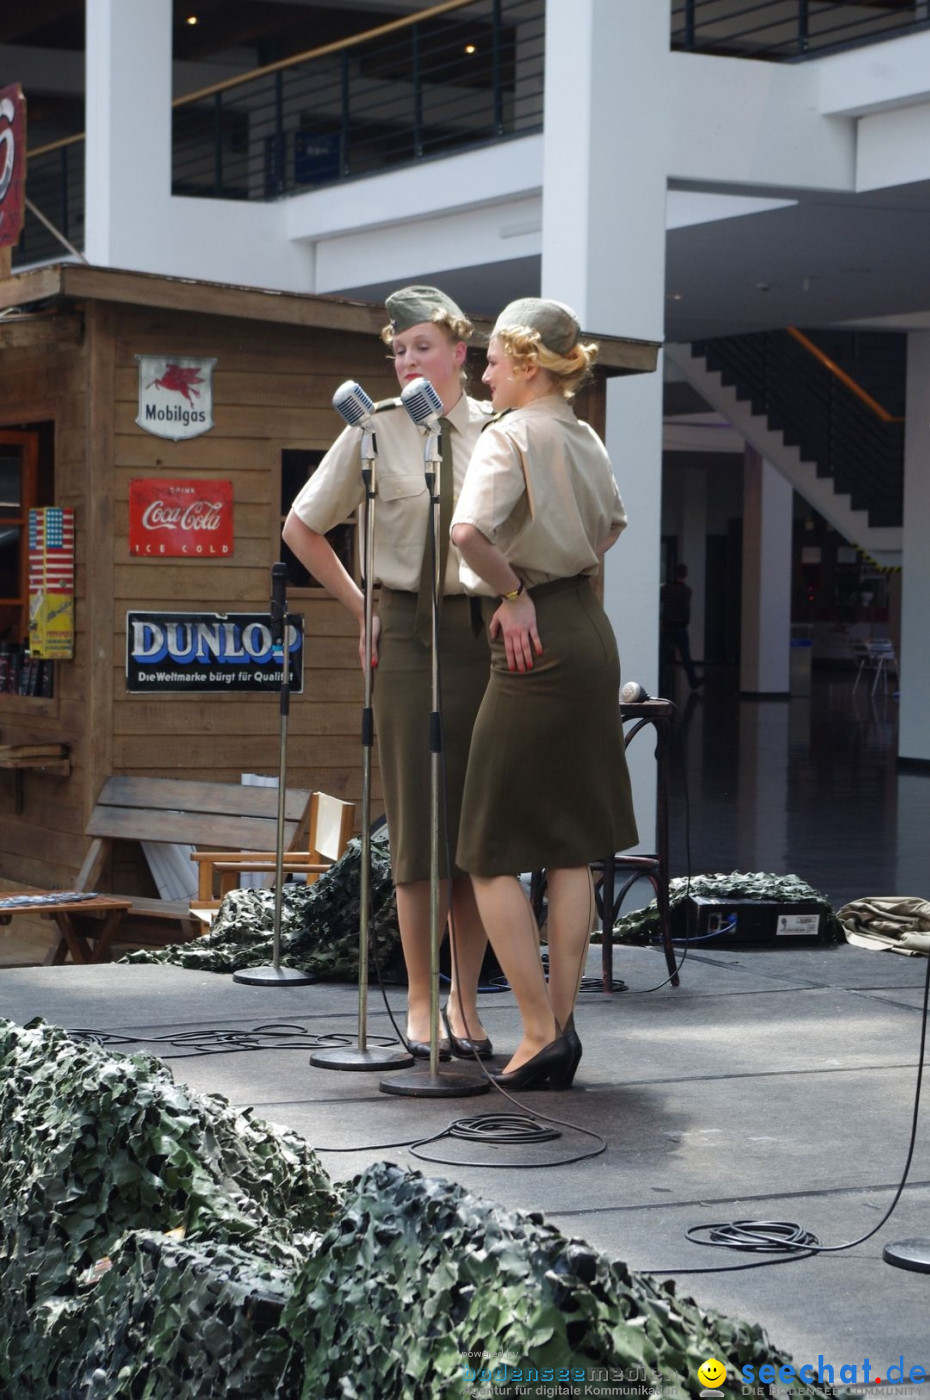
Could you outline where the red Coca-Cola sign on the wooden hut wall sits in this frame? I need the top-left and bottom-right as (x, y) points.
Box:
(129, 480), (233, 559)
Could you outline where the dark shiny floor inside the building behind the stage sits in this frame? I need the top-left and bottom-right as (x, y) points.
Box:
(669, 666), (930, 909)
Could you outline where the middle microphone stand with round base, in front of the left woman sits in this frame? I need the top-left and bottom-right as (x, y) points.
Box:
(310, 420), (413, 1070)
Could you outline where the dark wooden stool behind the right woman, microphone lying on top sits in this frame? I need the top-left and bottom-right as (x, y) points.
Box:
(591, 699), (679, 991)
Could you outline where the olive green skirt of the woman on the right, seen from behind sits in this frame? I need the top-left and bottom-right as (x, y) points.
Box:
(457, 577), (637, 876)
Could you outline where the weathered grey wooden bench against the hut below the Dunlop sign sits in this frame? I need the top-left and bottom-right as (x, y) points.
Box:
(74, 777), (312, 937)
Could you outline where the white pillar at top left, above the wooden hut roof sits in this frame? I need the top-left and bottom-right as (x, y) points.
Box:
(84, 0), (171, 267)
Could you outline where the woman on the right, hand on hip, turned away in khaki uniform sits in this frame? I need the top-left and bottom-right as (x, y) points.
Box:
(451, 298), (637, 1089)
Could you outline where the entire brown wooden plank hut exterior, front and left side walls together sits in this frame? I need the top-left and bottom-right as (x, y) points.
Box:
(0, 301), (604, 892)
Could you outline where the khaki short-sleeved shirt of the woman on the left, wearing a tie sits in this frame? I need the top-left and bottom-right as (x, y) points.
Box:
(293, 393), (490, 594)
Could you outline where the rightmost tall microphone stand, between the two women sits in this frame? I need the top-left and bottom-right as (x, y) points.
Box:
(380, 417), (490, 1099)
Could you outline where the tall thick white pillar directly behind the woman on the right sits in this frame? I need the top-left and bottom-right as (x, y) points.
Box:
(542, 0), (669, 848)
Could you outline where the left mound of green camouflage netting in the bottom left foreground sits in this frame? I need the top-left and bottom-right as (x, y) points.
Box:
(0, 1021), (340, 1400)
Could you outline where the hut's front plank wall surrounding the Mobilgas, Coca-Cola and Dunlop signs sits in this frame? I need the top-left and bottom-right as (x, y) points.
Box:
(111, 298), (396, 804)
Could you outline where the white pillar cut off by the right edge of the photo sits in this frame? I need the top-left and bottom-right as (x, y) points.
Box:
(898, 330), (930, 762)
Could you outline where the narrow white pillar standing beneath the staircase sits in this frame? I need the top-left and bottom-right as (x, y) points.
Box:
(740, 447), (794, 694)
